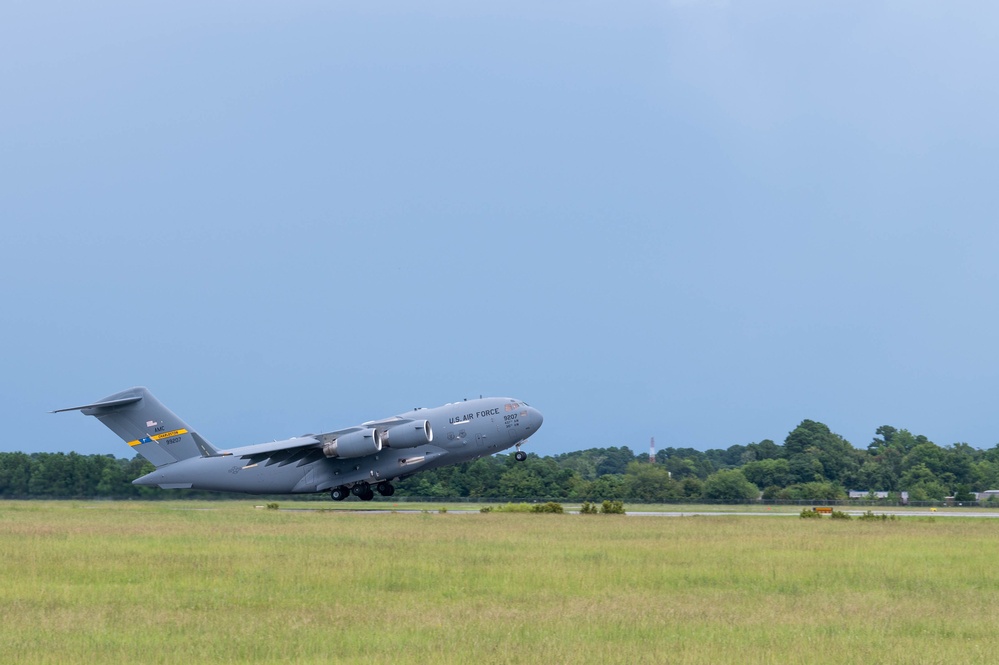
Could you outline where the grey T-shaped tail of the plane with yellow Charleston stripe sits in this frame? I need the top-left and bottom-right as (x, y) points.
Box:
(52, 387), (218, 467)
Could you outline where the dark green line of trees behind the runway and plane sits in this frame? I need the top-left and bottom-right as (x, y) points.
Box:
(0, 420), (999, 502)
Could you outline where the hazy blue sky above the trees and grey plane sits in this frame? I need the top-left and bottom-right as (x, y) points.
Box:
(0, 0), (999, 456)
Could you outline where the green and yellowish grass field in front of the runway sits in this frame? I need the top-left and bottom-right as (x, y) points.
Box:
(0, 501), (999, 665)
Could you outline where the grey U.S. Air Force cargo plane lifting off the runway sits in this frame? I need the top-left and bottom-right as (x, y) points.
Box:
(52, 387), (544, 501)
